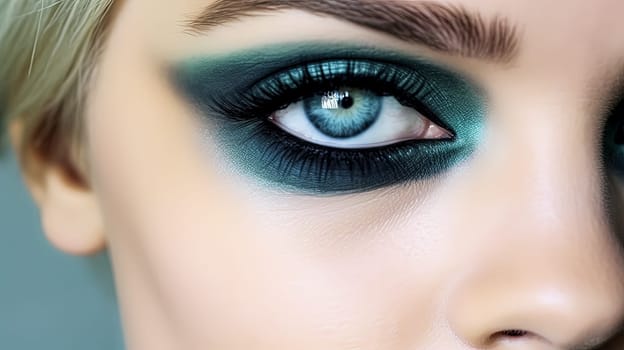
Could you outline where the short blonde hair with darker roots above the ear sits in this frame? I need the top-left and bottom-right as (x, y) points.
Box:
(0, 0), (113, 180)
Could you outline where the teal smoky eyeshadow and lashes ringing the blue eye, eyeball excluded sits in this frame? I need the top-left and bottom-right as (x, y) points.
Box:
(169, 43), (486, 194)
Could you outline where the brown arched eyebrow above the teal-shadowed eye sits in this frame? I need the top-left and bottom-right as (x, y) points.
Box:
(186, 0), (519, 63)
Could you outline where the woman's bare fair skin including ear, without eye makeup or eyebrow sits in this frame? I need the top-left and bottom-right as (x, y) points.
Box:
(14, 0), (624, 350)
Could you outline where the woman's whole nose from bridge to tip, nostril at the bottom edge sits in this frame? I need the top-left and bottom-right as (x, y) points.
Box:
(446, 114), (624, 349)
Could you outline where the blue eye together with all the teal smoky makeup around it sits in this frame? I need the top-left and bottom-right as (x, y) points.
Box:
(170, 43), (486, 194)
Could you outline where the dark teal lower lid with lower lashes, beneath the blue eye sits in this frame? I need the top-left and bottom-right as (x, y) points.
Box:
(220, 117), (452, 193)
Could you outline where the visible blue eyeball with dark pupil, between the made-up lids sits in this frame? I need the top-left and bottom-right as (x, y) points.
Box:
(269, 87), (453, 149)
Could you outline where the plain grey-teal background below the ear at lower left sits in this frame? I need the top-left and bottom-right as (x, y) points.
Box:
(0, 153), (123, 350)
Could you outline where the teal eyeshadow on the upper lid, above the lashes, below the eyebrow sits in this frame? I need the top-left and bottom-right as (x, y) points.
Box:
(170, 42), (487, 130)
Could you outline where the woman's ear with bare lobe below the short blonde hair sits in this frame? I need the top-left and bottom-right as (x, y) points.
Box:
(9, 122), (105, 255)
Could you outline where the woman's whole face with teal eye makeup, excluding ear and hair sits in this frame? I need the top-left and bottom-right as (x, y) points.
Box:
(77, 0), (624, 350)
